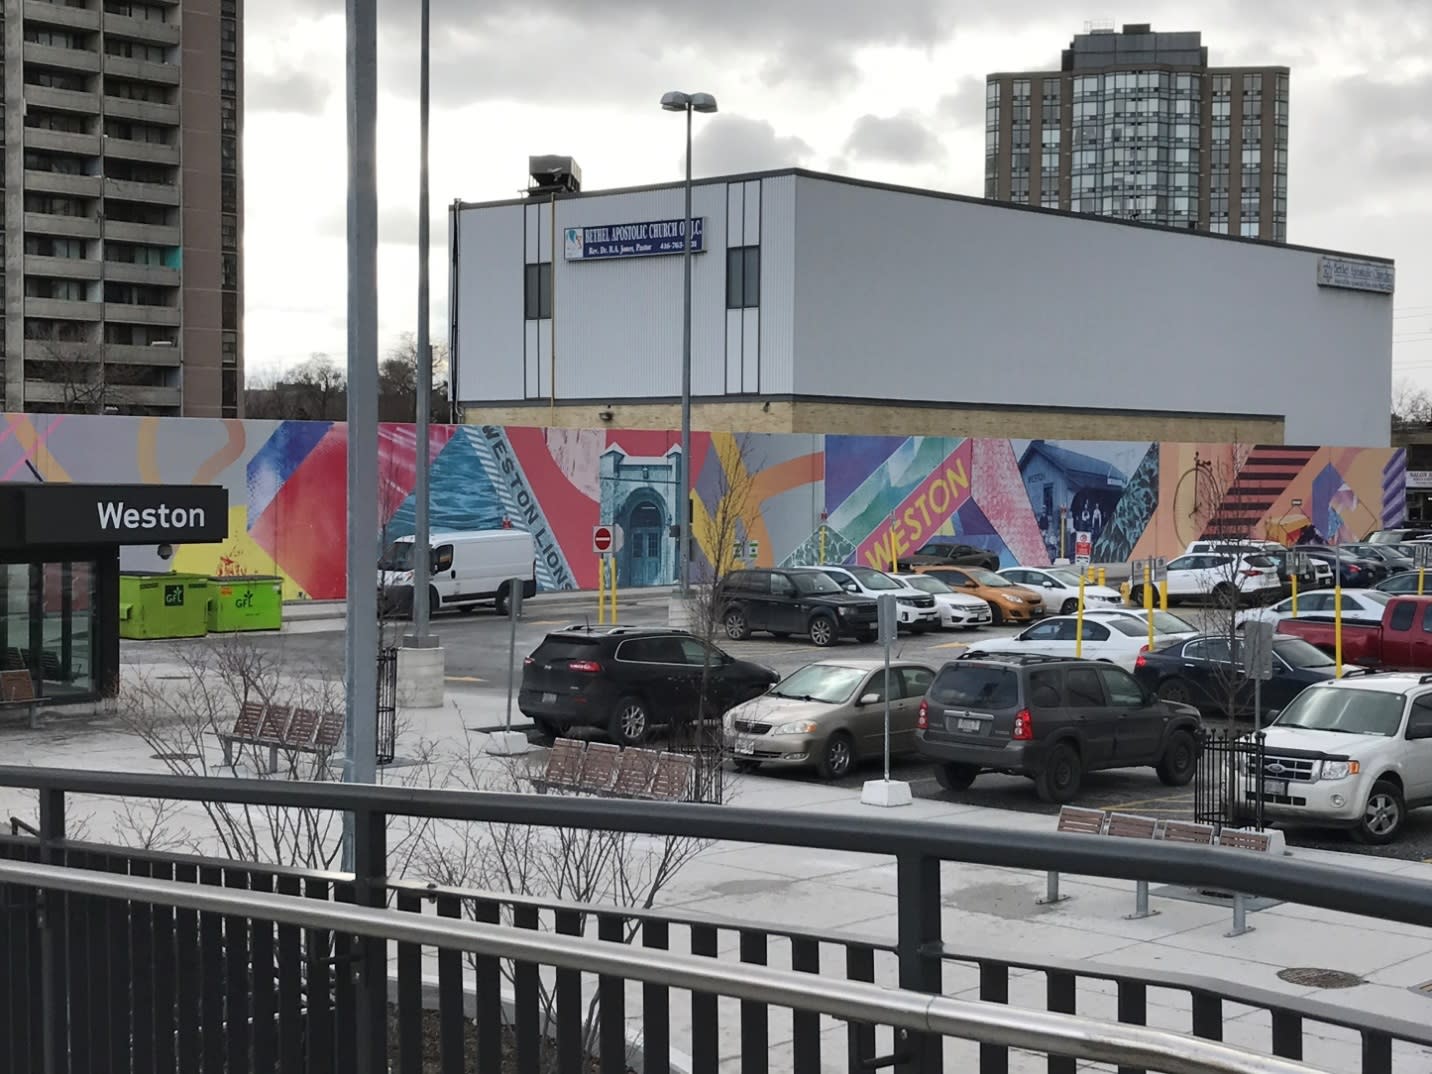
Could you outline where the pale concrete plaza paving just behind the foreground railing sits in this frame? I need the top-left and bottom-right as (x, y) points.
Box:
(0, 664), (1432, 1074)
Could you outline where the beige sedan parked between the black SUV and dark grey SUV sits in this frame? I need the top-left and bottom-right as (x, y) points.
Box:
(723, 660), (935, 779)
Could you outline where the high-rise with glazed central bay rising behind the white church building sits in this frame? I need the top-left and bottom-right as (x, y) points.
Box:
(985, 23), (1287, 242)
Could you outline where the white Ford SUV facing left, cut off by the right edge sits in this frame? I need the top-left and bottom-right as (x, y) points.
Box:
(1234, 673), (1432, 843)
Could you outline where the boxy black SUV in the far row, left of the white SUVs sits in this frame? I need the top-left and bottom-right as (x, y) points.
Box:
(716, 570), (879, 647)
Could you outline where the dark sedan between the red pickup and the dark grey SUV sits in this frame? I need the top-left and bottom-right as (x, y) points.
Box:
(1134, 634), (1336, 716)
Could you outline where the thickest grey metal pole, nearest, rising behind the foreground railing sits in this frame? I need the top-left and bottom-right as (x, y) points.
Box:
(344, 0), (379, 824)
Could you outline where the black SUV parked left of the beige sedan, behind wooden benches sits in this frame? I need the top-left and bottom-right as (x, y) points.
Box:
(517, 626), (780, 746)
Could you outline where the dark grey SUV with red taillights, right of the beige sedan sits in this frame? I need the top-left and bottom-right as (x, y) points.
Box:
(915, 654), (1199, 802)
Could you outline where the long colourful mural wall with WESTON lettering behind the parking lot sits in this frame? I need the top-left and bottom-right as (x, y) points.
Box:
(0, 414), (1406, 599)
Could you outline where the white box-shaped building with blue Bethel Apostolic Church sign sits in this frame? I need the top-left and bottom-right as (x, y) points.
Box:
(451, 159), (1393, 447)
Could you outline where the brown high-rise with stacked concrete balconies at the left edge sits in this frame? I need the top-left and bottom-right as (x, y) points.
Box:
(0, 0), (243, 417)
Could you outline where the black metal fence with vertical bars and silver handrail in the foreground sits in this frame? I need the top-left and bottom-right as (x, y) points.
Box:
(0, 768), (1432, 1074)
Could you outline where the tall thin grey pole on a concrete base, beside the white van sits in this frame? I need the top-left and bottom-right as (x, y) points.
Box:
(404, 0), (437, 649)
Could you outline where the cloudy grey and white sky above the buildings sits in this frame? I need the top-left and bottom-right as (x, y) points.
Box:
(243, 0), (1432, 390)
